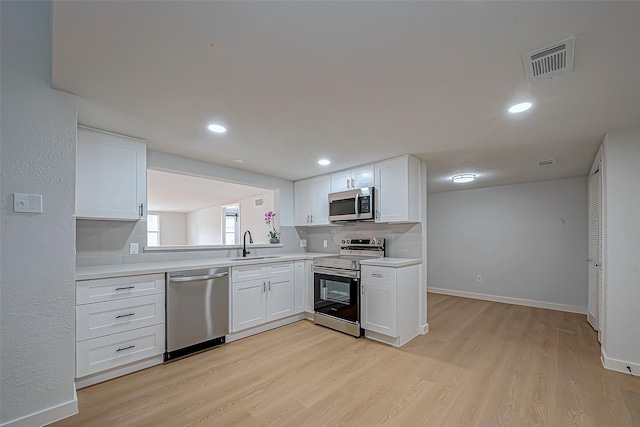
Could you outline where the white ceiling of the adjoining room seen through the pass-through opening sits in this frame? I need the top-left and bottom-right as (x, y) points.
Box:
(147, 169), (272, 212)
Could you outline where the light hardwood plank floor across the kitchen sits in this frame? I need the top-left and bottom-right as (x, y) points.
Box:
(54, 294), (640, 427)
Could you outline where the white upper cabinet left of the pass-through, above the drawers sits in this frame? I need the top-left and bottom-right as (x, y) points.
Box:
(76, 127), (147, 221)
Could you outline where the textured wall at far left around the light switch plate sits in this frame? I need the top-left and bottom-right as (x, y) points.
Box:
(0, 1), (77, 425)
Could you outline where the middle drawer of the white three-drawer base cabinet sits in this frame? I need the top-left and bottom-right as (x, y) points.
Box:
(76, 294), (164, 341)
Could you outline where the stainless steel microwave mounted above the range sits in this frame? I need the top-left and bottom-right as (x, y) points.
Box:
(329, 187), (375, 222)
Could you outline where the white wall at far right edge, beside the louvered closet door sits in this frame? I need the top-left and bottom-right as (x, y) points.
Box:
(602, 126), (640, 375)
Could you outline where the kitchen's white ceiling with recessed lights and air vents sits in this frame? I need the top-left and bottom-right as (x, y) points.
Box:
(53, 1), (640, 191)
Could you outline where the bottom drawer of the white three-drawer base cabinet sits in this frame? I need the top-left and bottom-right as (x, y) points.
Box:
(76, 325), (164, 378)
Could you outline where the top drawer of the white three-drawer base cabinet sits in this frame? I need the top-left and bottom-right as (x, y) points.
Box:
(76, 274), (164, 305)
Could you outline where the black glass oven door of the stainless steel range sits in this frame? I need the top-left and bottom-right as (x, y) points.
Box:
(313, 267), (360, 324)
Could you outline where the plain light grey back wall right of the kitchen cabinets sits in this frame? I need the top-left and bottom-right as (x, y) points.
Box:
(427, 177), (587, 312)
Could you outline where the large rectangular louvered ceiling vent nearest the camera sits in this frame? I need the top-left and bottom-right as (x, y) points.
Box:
(522, 36), (576, 84)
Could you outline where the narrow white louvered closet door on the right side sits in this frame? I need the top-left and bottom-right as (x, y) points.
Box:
(587, 170), (603, 338)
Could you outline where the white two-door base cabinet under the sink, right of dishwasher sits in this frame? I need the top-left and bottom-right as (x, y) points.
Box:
(231, 262), (296, 332)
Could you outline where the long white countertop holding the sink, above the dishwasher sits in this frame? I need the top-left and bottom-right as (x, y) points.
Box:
(76, 252), (335, 280)
